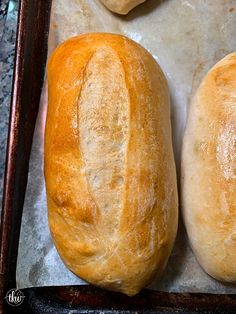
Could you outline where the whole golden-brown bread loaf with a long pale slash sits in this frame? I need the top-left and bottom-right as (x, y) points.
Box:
(45, 33), (178, 295)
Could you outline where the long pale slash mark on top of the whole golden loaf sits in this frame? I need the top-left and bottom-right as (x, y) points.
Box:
(78, 46), (130, 233)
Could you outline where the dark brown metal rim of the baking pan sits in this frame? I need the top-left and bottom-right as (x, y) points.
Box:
(0, 0), (236, 314)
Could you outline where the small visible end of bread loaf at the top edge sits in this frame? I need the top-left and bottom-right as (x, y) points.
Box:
(100, 0), (146, 14)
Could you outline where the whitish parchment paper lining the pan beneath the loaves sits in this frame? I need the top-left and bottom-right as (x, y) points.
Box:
(17, 0), (236, 293)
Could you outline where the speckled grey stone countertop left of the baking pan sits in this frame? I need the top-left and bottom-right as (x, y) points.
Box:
(0, 0), (19, 208)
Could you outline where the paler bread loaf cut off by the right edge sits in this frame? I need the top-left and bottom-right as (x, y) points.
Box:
(182, 53), (236, 283)
